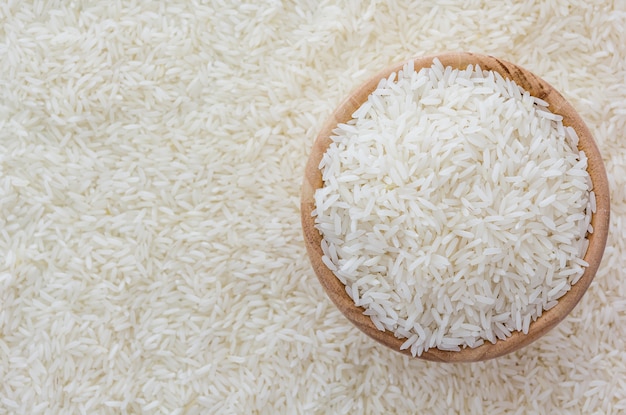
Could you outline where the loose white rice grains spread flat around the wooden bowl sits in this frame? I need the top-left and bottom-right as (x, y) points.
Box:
(0, 0), (626, 414)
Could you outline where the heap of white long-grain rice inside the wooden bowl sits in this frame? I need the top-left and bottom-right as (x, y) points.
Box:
(313, 59), (595, 356)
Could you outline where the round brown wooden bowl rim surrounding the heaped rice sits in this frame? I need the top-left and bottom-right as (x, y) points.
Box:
(301, 53), (609, 362)
